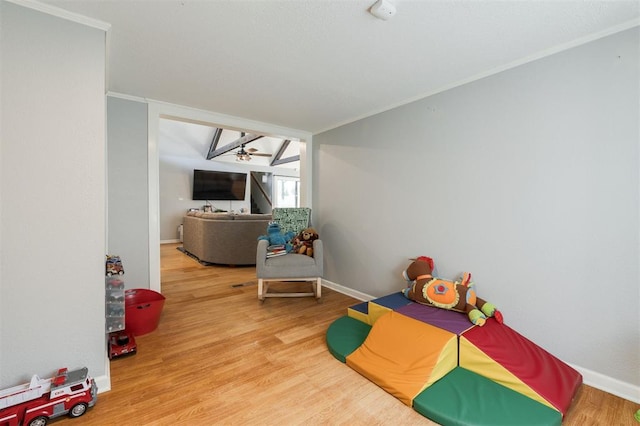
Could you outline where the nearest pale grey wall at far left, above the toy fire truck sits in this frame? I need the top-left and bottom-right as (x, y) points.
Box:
(0, 1), (106, 387)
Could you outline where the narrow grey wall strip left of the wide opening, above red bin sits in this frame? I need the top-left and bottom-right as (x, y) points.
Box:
(107, 96), (150, 288)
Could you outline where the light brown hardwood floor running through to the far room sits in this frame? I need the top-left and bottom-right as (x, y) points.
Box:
(57, 244), (640, 426)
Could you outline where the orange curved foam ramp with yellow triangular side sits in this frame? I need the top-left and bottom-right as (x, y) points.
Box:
(347, 311), (458, 406)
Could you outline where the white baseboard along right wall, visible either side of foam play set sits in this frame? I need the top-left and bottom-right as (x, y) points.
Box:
(322, 279), (640, 403)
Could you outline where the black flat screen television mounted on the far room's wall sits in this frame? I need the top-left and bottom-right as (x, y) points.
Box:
(192, 170), (247, 200)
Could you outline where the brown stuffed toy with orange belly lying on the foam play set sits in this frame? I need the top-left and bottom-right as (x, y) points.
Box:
(403, 256), (502, 326)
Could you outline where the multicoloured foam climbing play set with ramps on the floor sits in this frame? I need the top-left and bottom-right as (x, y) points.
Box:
(326, 258), (582, 425)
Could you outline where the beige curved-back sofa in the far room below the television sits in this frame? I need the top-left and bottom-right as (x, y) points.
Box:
(182, 212), (271, 265)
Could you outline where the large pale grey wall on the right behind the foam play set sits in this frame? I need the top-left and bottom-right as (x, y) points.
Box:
(313, 28), (640, 400)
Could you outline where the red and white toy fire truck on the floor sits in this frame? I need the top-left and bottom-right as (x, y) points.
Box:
(0, 367), (98, 426)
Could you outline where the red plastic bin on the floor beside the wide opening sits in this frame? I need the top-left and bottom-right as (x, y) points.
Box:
(124, 288), (165, 336)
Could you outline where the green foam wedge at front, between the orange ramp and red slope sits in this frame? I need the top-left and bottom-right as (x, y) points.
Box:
(413, 367), (562, 426)
